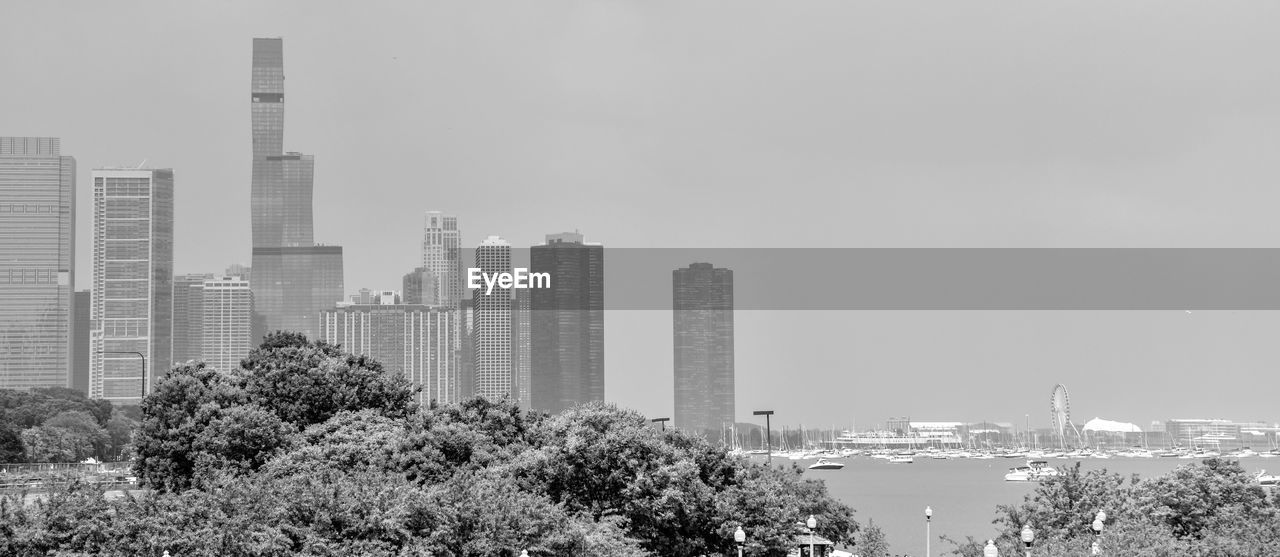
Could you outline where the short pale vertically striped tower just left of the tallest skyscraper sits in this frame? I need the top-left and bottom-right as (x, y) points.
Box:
(200, 277), (253, 371)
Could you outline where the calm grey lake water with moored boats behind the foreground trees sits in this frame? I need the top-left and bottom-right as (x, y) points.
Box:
(774, 457), (1280, 556)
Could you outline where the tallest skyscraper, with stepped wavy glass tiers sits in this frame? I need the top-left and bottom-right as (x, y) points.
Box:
(250, 38), (343, 342)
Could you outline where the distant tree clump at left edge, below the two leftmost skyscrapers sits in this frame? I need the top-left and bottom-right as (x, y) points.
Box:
(0, 388), (136, 462)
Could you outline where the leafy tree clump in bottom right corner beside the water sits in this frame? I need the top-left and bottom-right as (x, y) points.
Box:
(954, 458), (1280, 557)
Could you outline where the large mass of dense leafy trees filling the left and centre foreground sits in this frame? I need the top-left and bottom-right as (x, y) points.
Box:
(0, 333), (858, 557)
